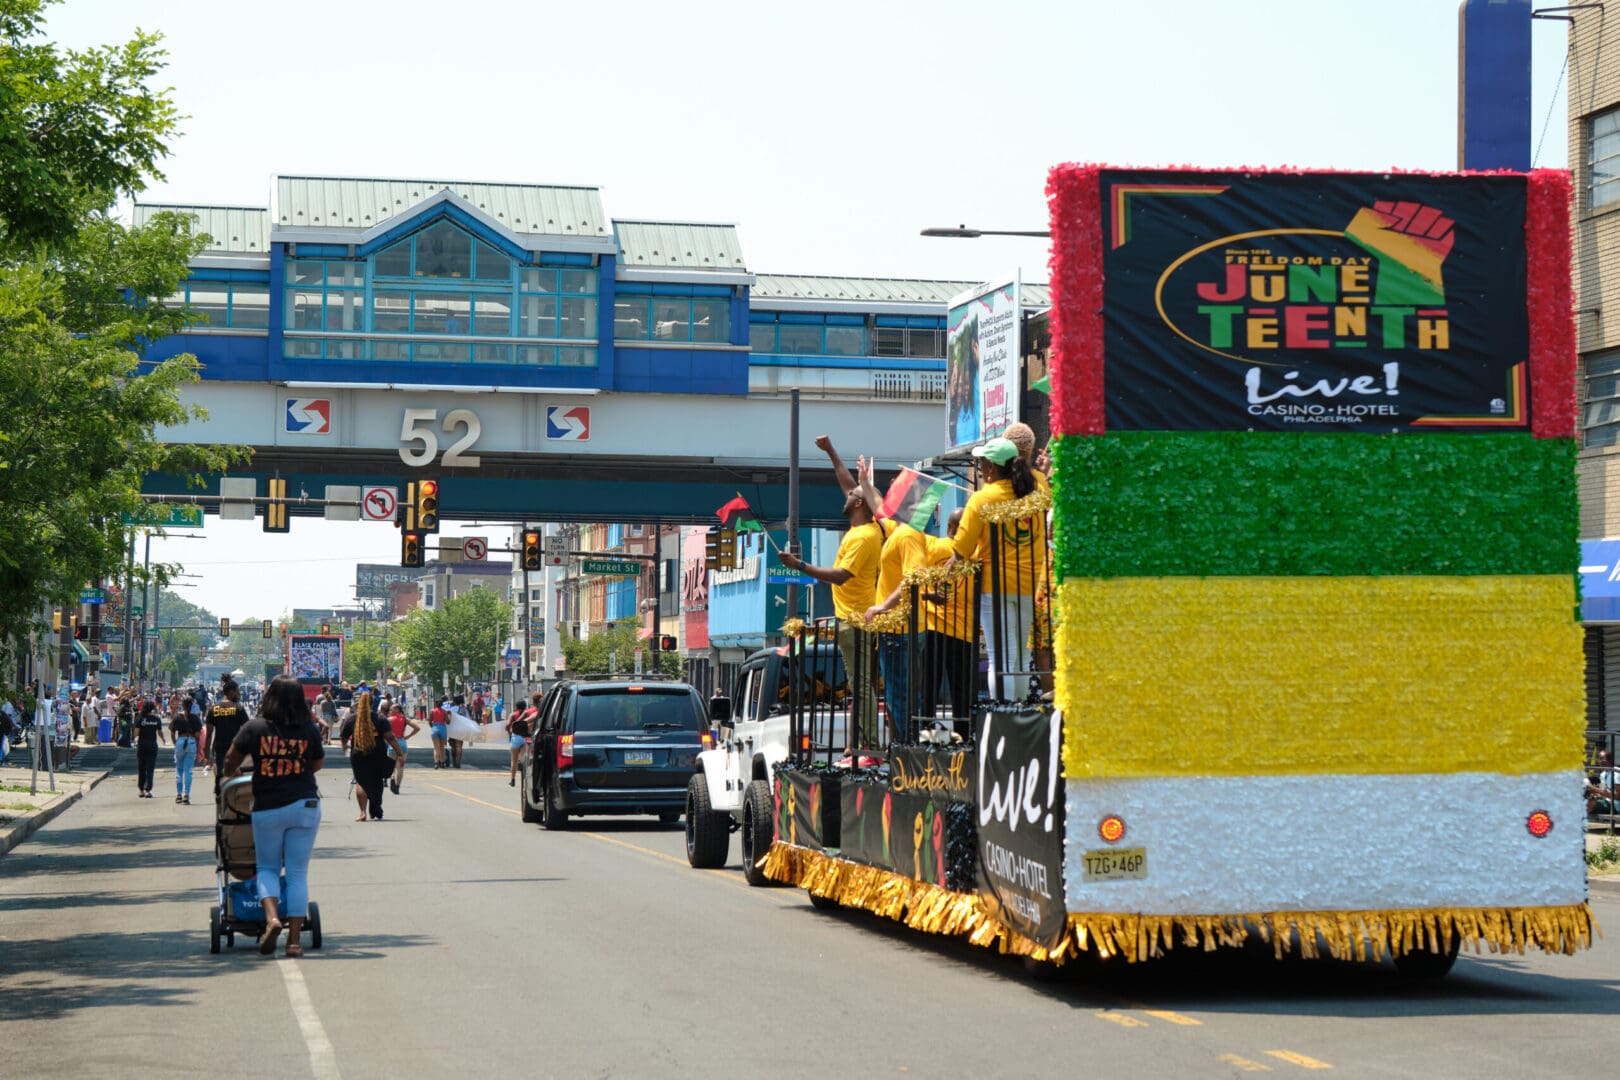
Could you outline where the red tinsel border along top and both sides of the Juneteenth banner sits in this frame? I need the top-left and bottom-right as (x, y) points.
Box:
(1047, 164), (1576, 439)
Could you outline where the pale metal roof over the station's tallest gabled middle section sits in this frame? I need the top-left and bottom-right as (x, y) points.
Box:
(274, 176), (612, 236)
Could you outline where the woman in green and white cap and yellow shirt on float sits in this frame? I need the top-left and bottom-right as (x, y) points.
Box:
(954, 437), (1047, 701)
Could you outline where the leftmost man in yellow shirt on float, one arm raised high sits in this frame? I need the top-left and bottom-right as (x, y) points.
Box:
(781, 436), (886, 750)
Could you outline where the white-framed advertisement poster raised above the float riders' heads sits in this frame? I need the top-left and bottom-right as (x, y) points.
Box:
(944, 277), (1024, 449)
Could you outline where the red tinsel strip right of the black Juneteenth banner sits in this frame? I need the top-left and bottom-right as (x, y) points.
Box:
(1524, 168), (1578, 439)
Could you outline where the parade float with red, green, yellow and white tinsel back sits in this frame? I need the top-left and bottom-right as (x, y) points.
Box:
(765, 165), (1596, 975)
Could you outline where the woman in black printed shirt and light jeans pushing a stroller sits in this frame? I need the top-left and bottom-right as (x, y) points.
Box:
(215, 675), (326, 959)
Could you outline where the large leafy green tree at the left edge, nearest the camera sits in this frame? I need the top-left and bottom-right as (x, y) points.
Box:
(0, 0), (246, 640)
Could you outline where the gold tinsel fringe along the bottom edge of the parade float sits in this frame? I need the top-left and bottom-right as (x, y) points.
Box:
(763, 842), (1602, 963)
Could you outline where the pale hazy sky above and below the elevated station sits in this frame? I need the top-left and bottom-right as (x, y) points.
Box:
(47, 0), (1568, 617)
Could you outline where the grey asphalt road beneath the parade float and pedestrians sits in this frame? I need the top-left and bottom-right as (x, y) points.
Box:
(0, 750), (1620, 1080)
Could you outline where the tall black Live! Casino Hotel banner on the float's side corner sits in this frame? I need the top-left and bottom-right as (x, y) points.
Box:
(974, 709), (1068, 947)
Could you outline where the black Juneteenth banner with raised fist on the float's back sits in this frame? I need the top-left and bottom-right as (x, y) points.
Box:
(1098, 170), (1533, 432)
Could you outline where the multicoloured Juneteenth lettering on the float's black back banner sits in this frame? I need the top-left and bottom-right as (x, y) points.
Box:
(1197, 253), (1452, 350)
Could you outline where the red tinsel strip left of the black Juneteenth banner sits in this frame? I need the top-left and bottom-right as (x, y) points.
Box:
(1047, 165), (1103, 436)
